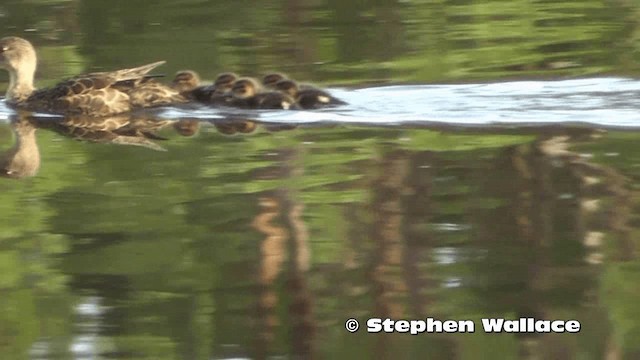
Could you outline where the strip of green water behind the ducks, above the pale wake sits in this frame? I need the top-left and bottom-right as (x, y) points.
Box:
(0, 0), (640, 85)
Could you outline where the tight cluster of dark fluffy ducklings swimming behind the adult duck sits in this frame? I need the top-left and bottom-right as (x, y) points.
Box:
(171, 70), (346, 110)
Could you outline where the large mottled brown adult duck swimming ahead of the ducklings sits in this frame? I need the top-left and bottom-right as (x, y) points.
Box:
(0, 37), (186, 117)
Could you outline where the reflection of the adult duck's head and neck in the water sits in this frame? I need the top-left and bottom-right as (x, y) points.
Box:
(0, 114), (40, 179)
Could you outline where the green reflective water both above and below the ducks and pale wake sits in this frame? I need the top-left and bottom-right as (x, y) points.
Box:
(0, 0), (640, 359)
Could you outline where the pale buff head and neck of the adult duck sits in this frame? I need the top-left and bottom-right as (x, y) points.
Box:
(0, 36), (38, 100)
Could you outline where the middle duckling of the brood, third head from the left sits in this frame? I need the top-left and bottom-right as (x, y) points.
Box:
(230, 78), (296, 110)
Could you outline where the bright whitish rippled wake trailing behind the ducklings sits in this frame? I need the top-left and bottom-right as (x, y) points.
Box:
(0, 78), (640, 128)
